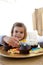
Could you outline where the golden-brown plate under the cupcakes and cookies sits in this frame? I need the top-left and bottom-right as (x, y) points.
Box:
(0, 47), (43, 58)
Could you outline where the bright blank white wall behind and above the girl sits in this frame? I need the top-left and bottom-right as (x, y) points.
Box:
(0, 0), (43, 35)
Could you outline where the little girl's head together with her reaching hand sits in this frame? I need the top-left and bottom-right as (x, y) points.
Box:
(3, 22), (27, 47)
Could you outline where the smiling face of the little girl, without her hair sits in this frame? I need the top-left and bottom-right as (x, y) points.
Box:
(13, 26), (24, 40)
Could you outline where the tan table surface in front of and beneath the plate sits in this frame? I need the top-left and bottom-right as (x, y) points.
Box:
(0, 46), (43, 65)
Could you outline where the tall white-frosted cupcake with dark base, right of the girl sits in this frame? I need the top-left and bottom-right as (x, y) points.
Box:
(27, 31), (38, 48)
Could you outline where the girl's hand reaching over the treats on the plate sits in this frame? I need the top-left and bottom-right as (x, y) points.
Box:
(3, 36), (19, 47)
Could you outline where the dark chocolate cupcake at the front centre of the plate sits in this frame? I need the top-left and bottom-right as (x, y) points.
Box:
(19, 43), (31, 54)
